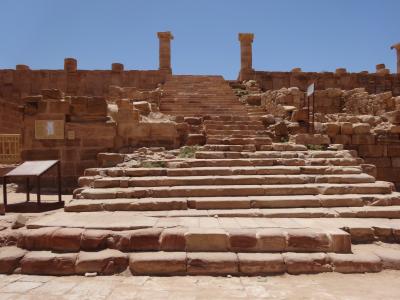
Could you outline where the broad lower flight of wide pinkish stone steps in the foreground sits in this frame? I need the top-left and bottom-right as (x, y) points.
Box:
(0, 142), (400, 275)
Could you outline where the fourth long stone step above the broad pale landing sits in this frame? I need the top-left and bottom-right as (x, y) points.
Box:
(85, 166), (362, 177)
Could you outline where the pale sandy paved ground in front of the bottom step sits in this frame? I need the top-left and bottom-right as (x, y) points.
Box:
(0, 271), (400, 300)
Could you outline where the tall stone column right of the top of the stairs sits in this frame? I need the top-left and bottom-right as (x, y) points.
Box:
(239, 33), (254, 80)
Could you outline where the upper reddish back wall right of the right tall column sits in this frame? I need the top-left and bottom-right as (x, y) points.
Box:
(250, 71), (400, 96)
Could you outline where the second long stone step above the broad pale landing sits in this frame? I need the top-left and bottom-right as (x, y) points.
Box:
(80, 181), (394, 199)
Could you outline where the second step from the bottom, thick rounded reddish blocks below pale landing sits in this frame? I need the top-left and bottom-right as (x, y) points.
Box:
(11, 226), (351, 253)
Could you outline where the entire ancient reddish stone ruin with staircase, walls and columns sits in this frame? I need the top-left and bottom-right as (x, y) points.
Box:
(0, 32), (400, 275)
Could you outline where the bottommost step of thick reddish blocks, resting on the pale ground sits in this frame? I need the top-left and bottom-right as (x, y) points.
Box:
(0, 247), (390, 276)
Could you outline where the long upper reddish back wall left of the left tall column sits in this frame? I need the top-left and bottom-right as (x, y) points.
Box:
(0, 69), (167, 103)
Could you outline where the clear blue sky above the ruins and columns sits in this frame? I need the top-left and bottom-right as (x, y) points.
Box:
(0, 0), (400, 79)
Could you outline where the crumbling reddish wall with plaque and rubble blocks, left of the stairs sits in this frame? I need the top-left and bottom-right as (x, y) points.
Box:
(5, 89), (187, 191)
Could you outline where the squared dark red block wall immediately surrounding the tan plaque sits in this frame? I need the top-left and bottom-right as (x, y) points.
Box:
(21, 90), (116, 189)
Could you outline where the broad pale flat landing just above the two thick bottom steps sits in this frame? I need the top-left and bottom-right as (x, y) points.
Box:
(24, 211), (400, 243)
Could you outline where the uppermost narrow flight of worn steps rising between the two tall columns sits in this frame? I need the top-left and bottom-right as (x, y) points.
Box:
(160, 75), (246, 117)
